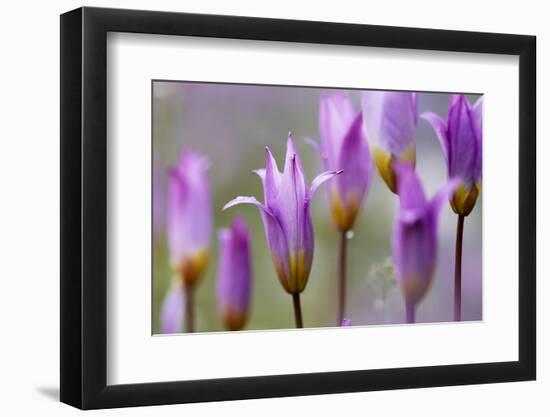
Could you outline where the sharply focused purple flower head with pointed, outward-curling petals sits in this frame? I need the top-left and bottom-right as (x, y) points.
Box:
(223, 134), (342, 294)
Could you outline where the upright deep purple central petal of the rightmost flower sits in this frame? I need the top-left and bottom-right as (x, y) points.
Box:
(447, 95), (481, 187)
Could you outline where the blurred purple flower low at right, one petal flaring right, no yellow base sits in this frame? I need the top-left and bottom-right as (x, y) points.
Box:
(393, 164), (456, 322)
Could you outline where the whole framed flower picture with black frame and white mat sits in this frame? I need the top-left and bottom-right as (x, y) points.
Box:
(61, 8), (536, 409)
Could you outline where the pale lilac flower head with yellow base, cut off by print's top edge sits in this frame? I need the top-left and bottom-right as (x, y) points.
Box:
(361, 91), (418, 193)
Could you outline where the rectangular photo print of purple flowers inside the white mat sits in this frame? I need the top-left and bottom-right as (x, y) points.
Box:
(152, 80), (483, 335)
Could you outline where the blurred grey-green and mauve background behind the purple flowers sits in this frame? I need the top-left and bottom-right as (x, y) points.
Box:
(152, 81), (483, 334)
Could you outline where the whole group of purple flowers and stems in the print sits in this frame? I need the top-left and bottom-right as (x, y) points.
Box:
(161, 91), (482, 333)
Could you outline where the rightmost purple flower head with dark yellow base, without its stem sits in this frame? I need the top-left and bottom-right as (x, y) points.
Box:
(421, 94), (483, 216)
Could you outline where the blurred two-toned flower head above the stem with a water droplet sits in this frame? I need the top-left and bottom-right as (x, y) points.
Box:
(310, 93), (372, 232)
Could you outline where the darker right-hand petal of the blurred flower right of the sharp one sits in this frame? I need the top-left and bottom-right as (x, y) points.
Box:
(335, 113), (372, 205)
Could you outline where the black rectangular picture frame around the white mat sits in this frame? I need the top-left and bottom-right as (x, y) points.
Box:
(60, 7), (536, 409)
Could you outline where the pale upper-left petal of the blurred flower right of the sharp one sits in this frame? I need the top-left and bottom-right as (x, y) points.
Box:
(319, 92), (355, 169)
